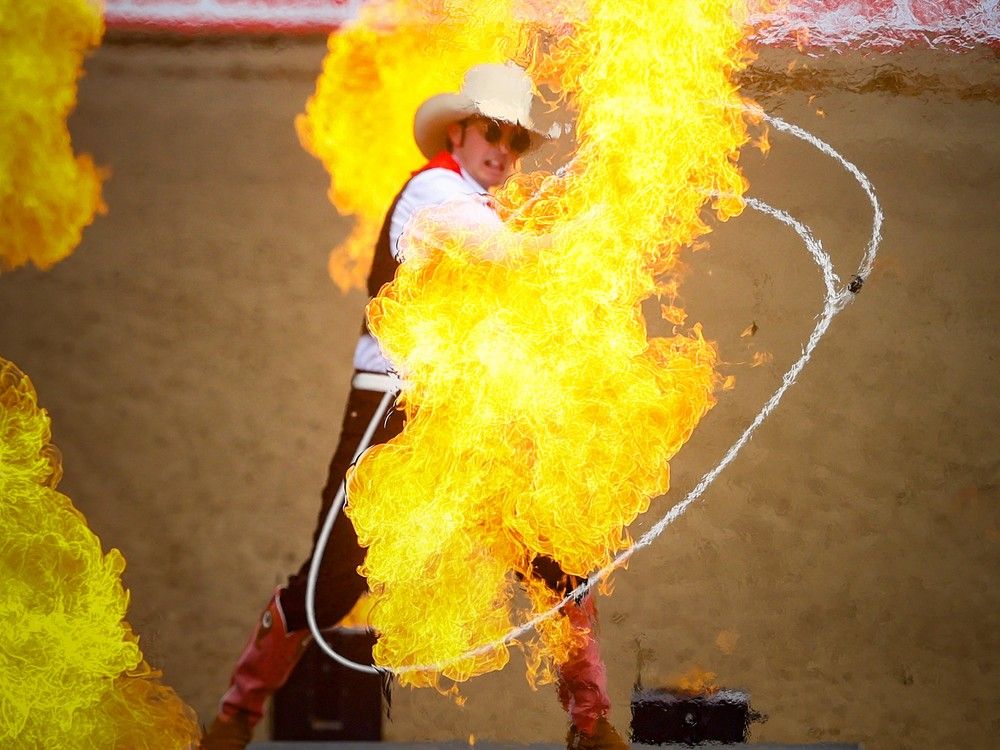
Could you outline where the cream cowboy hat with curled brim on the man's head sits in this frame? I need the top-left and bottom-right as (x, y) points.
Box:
(413, 63), (548, 159)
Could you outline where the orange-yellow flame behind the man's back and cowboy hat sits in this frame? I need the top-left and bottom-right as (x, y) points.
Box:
(296, 0), (521, 292)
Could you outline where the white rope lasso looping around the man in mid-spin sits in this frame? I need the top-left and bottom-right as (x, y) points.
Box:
(306, 113), (883, 675)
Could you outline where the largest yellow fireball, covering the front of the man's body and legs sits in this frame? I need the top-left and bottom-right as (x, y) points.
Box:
(307, 0), (749, 685)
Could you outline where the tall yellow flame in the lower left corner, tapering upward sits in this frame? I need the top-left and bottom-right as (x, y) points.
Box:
(0, 357), (198, 750)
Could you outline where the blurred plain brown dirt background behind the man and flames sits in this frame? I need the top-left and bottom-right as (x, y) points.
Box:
(0, 38), (1000, 750)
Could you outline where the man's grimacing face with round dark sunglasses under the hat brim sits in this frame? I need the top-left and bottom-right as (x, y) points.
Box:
(448, 117), (530, 188)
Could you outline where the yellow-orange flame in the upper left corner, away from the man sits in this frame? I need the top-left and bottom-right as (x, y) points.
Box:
(0, 0), (104, 271)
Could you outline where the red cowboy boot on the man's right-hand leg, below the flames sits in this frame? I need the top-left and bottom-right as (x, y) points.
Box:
(558, 595), (628, 750)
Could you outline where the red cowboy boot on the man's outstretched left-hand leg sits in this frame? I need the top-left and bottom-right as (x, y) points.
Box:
(200, 588), (310, 750)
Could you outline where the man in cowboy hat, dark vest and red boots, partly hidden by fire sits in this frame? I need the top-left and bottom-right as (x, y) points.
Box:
(201, 64), (627, 750)
